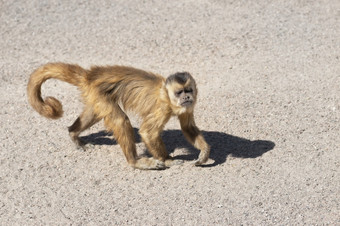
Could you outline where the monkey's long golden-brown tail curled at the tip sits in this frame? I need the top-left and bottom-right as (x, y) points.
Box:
(27, 63), (87, 119)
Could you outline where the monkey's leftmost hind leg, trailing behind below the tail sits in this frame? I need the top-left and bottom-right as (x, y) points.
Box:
(68, 107), (100, 150)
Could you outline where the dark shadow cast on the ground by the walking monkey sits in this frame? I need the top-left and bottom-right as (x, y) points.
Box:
(82, 128), (275, 167)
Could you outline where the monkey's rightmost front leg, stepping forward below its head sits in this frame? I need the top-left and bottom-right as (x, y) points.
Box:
(178, 113), (210, 166)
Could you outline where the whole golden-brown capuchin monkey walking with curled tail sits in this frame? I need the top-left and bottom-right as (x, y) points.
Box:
(27, 63), (210, 169)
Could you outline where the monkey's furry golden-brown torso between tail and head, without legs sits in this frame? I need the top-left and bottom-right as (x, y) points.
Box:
(83, 66), (165, 117)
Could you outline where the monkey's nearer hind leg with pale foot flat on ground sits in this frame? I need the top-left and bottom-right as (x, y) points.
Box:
(104, 105), (166, 170)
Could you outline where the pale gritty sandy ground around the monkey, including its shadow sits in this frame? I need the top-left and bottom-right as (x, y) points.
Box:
(0, 0), (340, 225)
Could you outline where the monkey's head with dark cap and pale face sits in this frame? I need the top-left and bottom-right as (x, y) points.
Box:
(165, 72), (197, 115)
